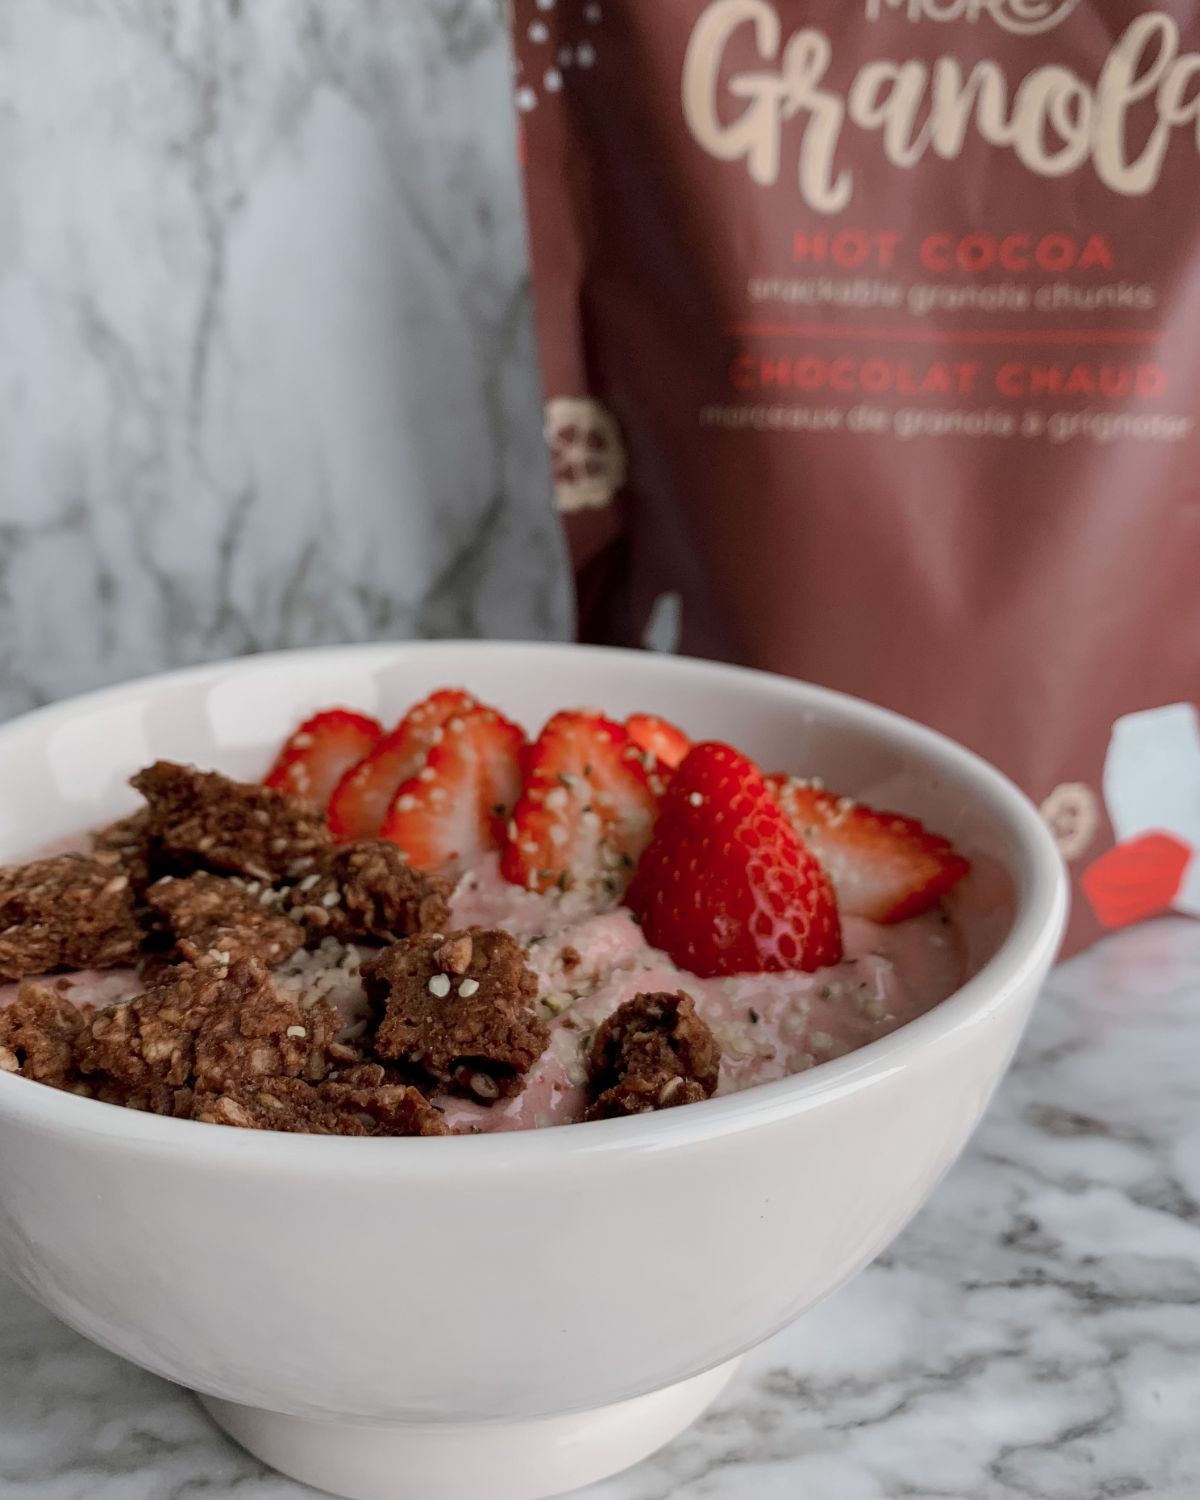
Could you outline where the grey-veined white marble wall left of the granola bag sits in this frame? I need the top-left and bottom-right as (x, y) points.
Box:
(0, 0), (570, 716)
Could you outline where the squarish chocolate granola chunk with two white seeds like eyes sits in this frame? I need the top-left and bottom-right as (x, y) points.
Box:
(363, 927), (549, 1103)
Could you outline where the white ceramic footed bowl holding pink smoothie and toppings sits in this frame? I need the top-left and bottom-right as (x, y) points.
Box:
(0, 644), (1065, 1500)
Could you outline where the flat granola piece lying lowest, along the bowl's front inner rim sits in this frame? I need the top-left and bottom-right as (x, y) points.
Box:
(192, 1079), (450, 1136)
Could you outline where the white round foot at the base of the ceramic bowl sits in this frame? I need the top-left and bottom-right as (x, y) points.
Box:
(200, 1359), (741, 1500)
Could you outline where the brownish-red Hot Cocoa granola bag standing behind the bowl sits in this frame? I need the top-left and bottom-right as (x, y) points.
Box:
(513, 0), (1200, 947)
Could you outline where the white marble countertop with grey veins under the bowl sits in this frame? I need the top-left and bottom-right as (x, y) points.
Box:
(0, 921), (1200, 1500)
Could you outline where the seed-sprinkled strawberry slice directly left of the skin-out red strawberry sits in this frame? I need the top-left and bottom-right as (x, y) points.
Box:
(500, 711), (659, 893)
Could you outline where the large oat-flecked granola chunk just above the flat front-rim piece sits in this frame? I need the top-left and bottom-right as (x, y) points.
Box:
(80, 960), (357, 1113)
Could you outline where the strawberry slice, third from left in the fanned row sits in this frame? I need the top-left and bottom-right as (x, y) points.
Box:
(380, 707), (525, 870)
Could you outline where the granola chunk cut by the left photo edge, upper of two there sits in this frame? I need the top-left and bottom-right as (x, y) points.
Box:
(0, 854), (143, 980)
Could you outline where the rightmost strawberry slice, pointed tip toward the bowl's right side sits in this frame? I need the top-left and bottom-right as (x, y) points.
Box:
(767, 776), (971, 923)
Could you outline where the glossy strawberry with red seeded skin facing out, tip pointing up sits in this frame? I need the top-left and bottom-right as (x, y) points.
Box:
(626, 743), (842, 978)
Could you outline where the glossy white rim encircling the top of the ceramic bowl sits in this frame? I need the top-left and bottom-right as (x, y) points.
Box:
(0, 639), (1068, 1176)
